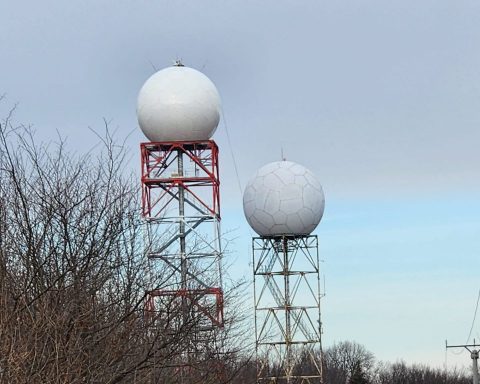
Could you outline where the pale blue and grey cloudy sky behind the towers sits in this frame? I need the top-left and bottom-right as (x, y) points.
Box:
(0, 0), (480, 365)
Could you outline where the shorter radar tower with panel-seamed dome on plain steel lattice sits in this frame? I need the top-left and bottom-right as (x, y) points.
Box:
(244, 161), (324, 384)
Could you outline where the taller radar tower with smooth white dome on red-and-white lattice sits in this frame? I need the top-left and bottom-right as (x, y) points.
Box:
(137, 63), (224, 359)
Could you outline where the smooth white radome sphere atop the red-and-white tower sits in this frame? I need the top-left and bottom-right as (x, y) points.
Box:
(137, 66), (220, 141)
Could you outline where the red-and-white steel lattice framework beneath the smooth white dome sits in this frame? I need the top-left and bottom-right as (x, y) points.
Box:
(140, 140), (223, 336)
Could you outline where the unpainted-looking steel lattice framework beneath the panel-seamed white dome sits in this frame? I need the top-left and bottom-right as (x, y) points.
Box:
(252, 236), (323, 384)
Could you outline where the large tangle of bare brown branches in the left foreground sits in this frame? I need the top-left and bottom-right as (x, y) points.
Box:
(0, 109), (248, 383)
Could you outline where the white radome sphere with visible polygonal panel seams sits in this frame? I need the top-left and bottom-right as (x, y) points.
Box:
(243, 161), (325, 237)
